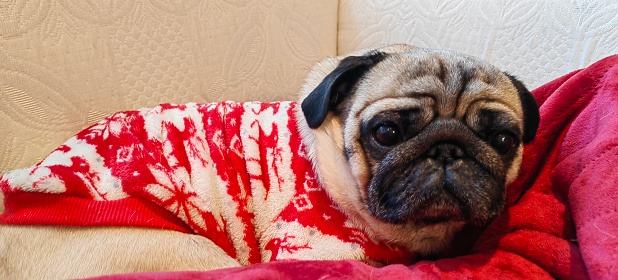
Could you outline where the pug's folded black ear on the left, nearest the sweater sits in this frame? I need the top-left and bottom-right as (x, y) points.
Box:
(301, 52), (385, 128)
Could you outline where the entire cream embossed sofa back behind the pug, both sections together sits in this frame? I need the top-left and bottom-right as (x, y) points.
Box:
(0, 0), (618, 201)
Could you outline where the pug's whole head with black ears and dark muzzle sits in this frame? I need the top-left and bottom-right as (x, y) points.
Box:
(301, 45), (539, 253)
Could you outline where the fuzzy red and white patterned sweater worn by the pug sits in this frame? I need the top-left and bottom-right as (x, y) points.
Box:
(0, 102), (413, 264)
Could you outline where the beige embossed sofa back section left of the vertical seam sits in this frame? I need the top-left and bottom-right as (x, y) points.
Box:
(0, 0), (338, 174)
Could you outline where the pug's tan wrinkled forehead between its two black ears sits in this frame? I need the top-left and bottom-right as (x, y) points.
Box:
(351, 47), (522, 121)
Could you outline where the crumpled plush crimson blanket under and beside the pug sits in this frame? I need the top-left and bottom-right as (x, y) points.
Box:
(3, 55), (618, 279)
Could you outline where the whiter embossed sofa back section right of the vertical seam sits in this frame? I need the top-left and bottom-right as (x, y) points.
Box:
(338, 0), (618, 89)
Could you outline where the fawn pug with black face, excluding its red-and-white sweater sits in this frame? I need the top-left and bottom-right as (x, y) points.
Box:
(0, 45), (539, 279)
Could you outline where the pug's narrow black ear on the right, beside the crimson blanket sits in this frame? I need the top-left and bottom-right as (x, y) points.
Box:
(504, 73), (541, 143)
